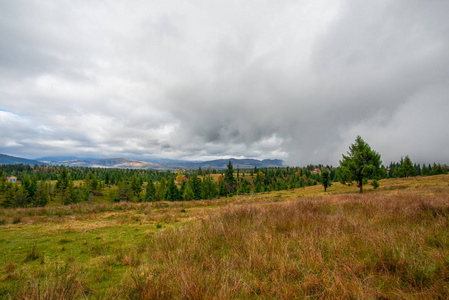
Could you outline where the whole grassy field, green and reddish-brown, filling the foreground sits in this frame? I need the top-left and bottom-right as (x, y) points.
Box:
(0, 175), (449, 299)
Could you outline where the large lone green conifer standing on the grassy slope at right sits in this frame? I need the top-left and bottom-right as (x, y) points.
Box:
(340, 136), (382, 193)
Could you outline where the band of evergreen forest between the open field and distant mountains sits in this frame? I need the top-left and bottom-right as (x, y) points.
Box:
(0, 156), (449, 208)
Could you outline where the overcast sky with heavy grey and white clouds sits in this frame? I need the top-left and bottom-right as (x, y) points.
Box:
(0, 0), (449, 166)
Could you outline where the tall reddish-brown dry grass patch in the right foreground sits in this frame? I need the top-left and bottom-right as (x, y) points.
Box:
(110, 190), (449, 299)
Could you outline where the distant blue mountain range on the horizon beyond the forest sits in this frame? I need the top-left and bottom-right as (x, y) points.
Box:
(0, 154), (283, 170)
